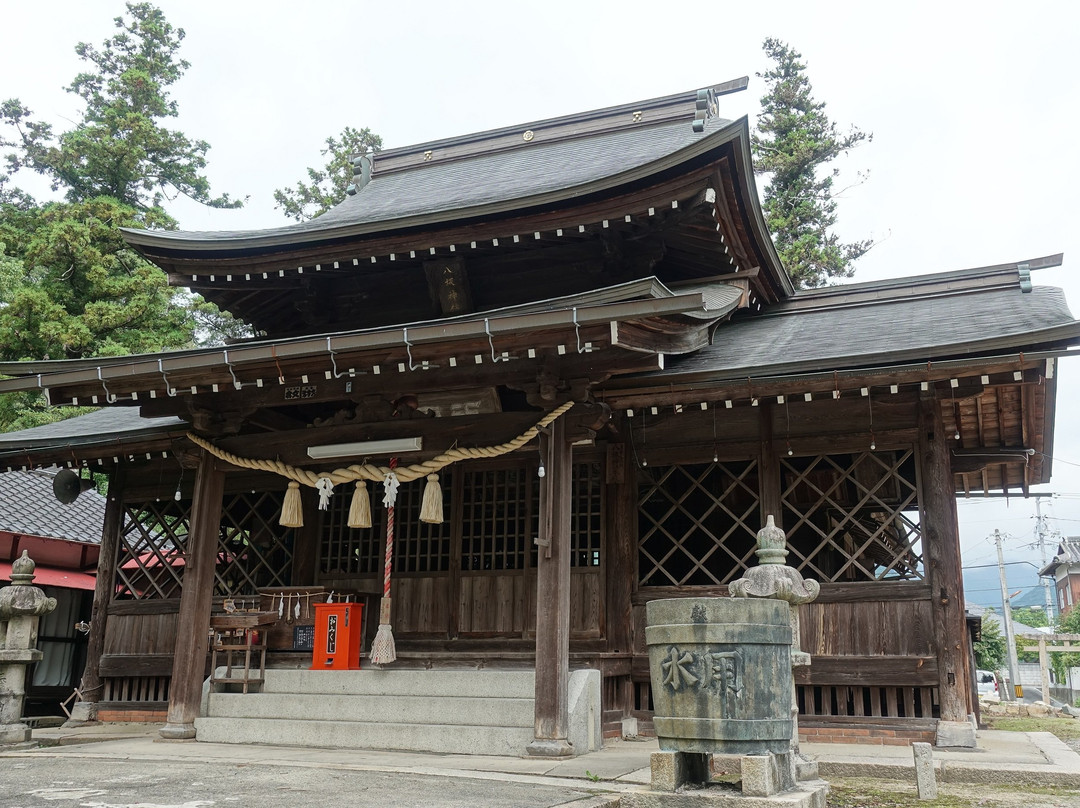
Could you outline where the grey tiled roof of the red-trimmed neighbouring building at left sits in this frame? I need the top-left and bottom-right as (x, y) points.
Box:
(0, 470), (105, 544)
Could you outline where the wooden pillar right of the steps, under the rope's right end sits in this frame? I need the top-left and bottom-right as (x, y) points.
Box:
(527, 418), (573, 757)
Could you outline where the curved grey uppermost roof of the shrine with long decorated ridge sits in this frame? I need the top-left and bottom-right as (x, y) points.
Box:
(124, 79), (748, 253)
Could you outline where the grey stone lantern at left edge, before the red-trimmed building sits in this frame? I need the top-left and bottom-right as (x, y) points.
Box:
(0, 550), (56, 743)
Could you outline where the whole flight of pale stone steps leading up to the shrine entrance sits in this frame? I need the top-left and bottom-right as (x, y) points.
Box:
(195, 669), (603, 756)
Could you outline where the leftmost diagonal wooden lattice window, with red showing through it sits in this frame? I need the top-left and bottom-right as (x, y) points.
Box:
(113, 499), (190, 600)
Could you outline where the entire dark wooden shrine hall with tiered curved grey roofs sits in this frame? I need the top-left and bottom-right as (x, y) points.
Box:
(0, 80), (1080, 754)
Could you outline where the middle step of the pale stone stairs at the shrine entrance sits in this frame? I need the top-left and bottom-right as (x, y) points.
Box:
(207, 692), (535, 728)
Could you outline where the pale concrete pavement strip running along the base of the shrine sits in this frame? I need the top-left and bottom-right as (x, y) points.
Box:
(6, 724), (1080, 808)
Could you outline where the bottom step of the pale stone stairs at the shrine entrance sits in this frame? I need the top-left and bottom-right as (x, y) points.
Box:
(195, 717), (532, 756)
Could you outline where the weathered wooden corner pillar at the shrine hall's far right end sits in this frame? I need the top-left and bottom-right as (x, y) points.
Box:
(919, 392), (972, 722)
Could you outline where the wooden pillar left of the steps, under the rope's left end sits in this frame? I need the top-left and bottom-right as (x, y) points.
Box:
(161, 450), (225, 739)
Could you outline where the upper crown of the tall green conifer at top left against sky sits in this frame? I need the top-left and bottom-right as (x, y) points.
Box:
(0, 3), (242, 226)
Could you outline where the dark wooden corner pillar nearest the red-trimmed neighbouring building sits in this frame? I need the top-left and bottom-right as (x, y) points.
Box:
(71, 466), (126, 721)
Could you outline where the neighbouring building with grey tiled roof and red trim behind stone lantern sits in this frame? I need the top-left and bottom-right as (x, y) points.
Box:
(0, 469), (105, 715)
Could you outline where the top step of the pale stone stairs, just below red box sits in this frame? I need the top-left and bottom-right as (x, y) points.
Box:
(255, 669), (536, 699)
